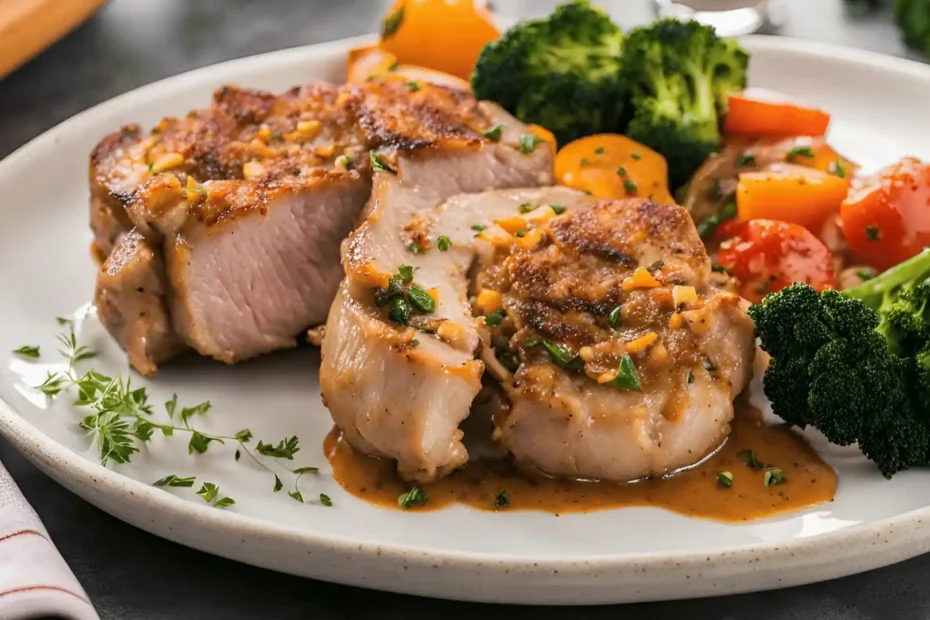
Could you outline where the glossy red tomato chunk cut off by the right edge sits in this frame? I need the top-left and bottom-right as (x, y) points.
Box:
(840, 157), (930, 270)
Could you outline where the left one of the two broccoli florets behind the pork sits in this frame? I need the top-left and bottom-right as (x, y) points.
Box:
(471, 0), (626, 144)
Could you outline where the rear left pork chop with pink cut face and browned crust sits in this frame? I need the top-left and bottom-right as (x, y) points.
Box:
(91, 79), (532, 375)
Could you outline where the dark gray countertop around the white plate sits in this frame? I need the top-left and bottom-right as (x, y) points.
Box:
(0, 0), (930, 620)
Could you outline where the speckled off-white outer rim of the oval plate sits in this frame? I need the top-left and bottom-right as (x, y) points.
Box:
(0, 36), (930, 604)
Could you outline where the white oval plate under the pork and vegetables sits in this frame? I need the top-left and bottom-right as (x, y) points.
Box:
(0, 37), (930, 604)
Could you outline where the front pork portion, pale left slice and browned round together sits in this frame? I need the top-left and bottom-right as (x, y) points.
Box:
(321, 176), (754, 481)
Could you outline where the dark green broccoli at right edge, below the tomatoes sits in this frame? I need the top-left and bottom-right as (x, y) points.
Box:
(749, 250), (930, 477)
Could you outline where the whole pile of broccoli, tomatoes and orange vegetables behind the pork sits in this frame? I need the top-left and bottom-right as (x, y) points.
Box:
(358, 0), (930, 476)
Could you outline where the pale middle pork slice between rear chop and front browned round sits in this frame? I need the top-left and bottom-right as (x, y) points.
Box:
(320, 88), (553, 482)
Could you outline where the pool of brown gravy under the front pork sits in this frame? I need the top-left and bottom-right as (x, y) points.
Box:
(323, 402), (836, 522)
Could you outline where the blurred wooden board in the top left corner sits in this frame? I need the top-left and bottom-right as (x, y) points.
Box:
(0, 0), (106, 78)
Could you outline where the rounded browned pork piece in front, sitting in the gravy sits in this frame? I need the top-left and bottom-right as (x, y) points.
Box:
(478, 199), (755, 481)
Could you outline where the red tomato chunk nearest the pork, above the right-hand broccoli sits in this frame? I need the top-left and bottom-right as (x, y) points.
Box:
(717, 219), (835, 303)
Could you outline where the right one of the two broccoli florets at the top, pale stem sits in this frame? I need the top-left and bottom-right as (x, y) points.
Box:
(621, 19), (749, 189)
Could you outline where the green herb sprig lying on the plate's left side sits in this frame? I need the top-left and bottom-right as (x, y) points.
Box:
(24, 319), (330, 508)
